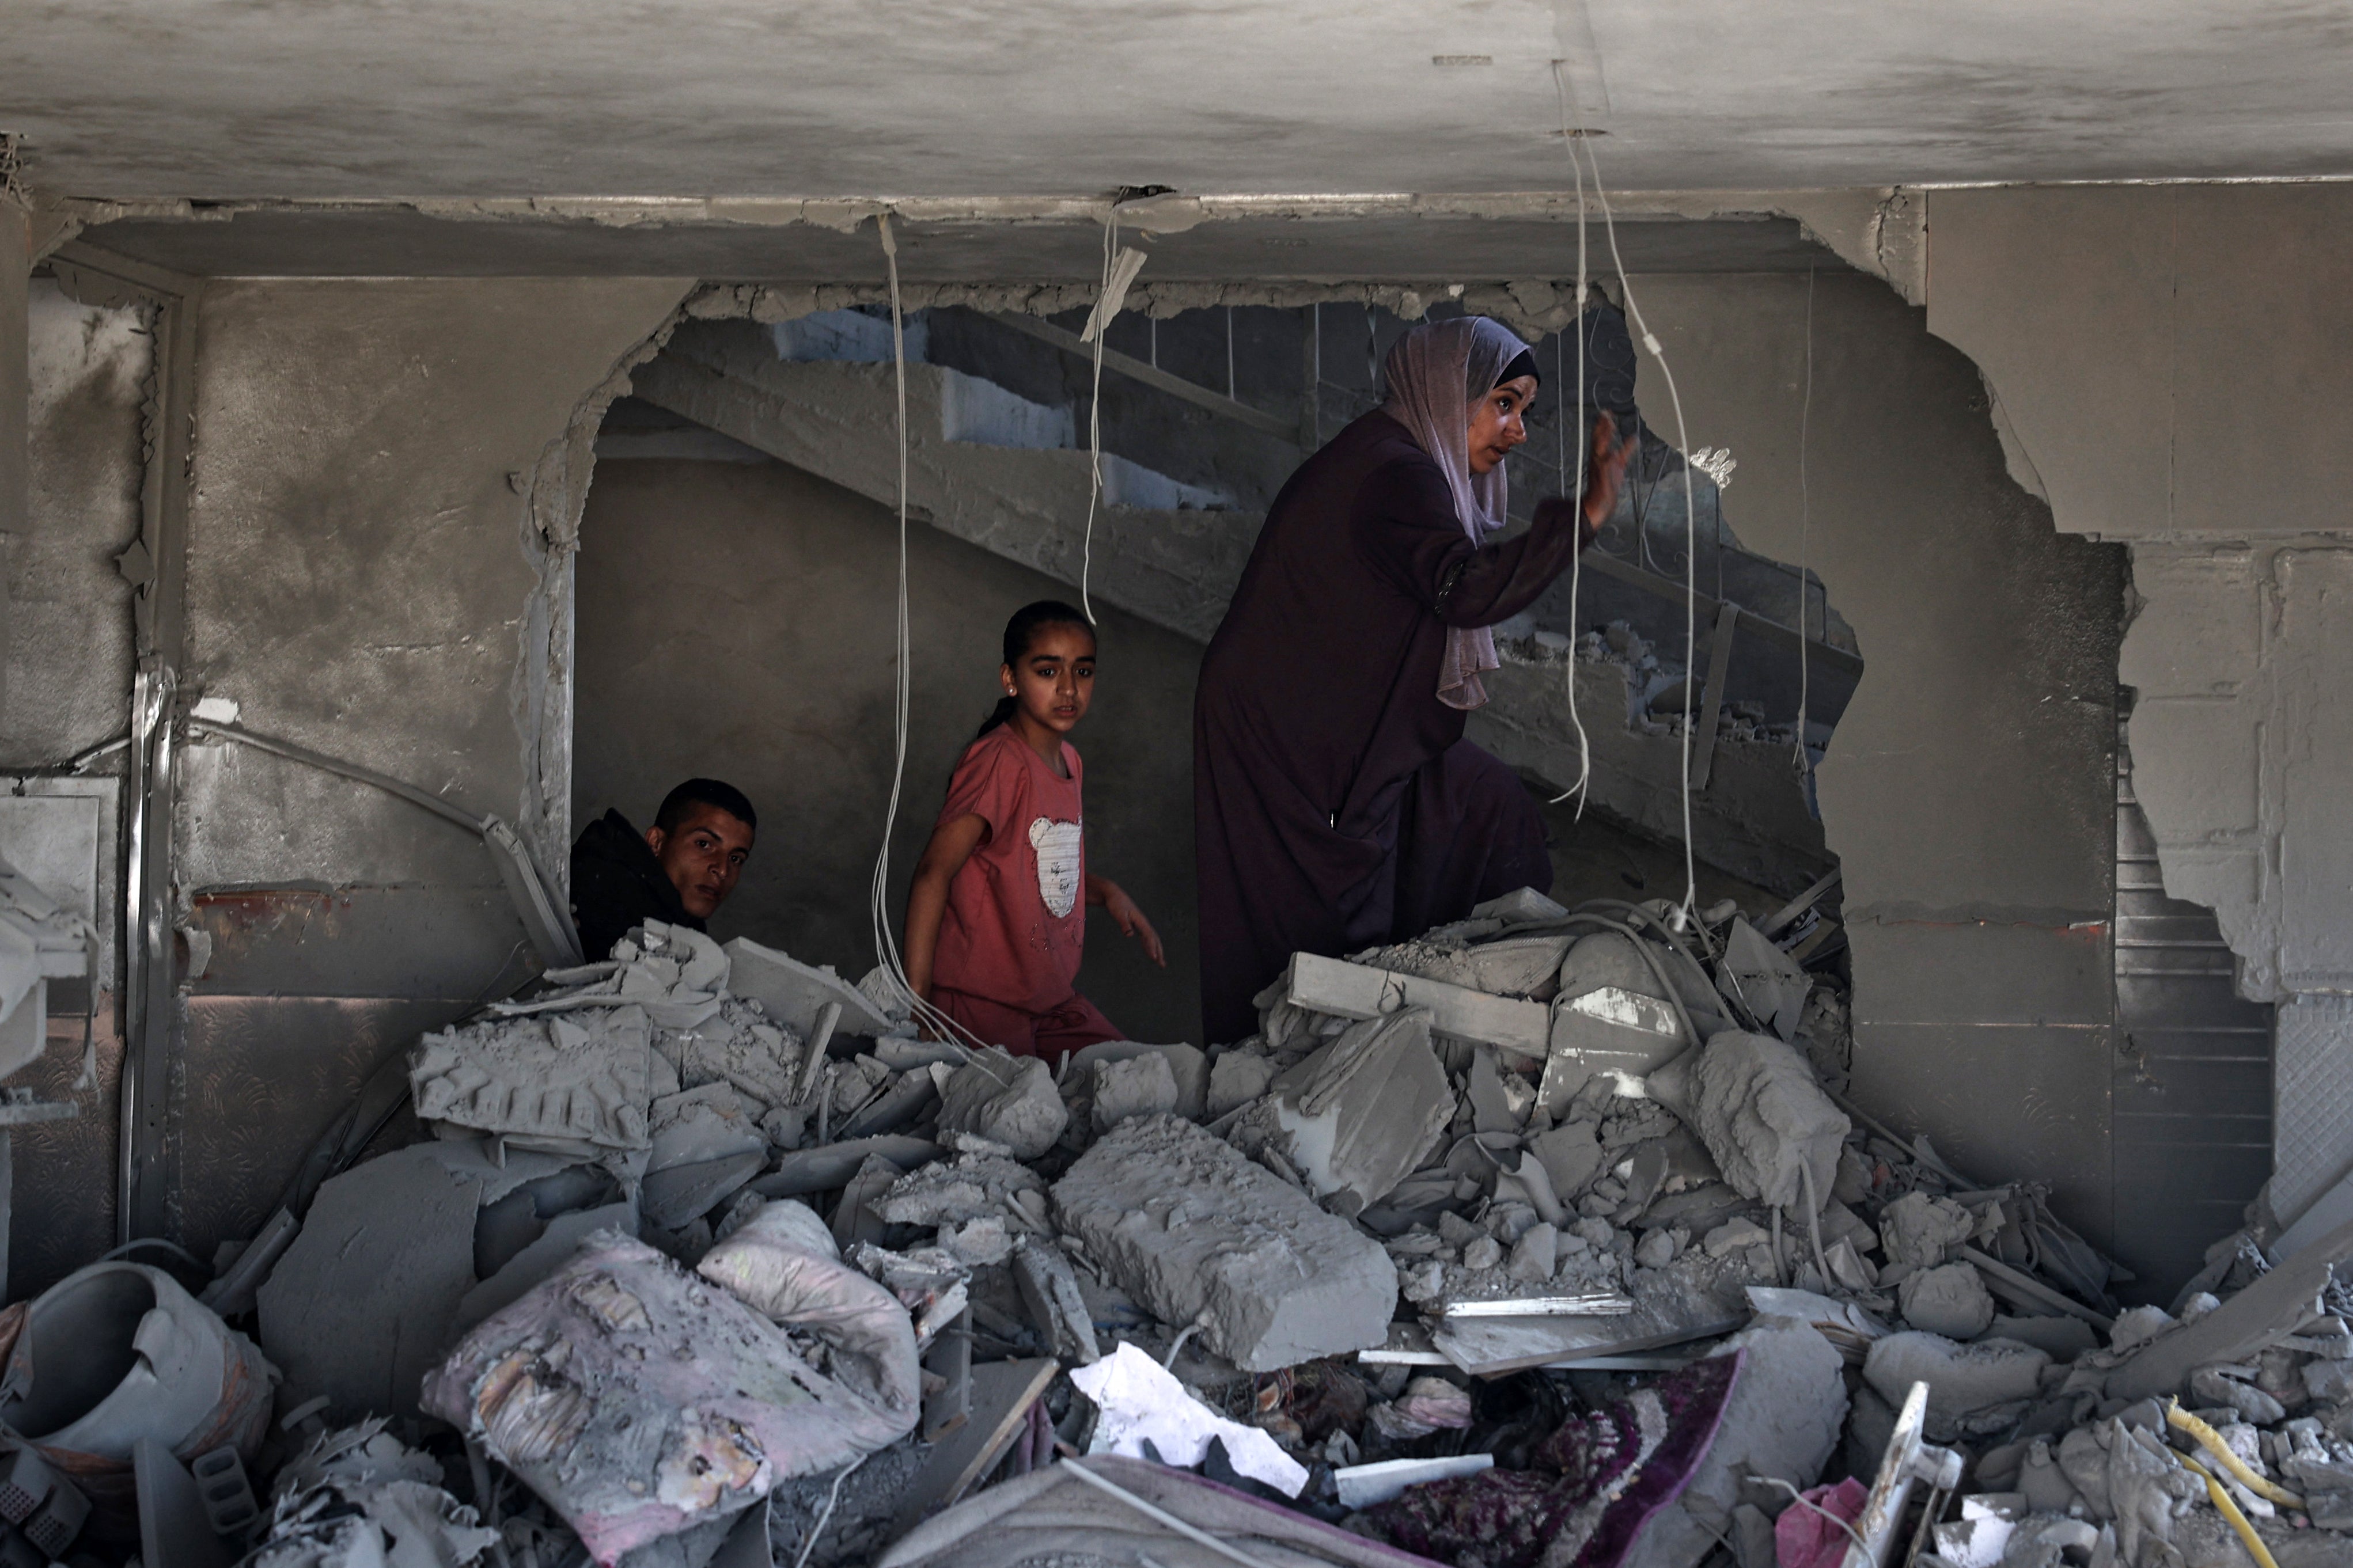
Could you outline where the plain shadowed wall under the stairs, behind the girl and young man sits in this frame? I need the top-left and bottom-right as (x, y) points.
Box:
(574, 451), (1200, 1044)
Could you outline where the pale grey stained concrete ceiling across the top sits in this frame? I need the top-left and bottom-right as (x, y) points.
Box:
(13, 0), (2353, 200)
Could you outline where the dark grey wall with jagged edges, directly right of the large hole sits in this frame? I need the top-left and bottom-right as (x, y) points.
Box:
(1600, 270), (2125, 1242)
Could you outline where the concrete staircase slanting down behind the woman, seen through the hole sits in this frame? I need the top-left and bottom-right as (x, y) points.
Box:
(633, 313), (1828, 891)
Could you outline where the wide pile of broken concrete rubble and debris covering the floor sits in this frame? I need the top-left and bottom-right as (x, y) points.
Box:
(0, 891), (2353, 1568)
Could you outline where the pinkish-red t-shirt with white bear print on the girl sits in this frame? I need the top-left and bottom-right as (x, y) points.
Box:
(932, 724), (1087, 1013)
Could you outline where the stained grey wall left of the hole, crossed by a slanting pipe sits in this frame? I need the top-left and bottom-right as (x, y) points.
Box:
(172, 280), (687, 1251)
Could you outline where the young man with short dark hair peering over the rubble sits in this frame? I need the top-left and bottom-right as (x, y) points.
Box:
(572, 778), (757, 962)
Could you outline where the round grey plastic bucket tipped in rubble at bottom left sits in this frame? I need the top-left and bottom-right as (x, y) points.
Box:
(0, 1262), (275, 1505)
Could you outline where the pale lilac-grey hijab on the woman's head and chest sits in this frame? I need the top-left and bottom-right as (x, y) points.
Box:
(1381, 315), (1527, 708)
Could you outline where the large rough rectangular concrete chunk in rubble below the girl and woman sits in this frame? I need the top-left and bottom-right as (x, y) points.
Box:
(1054, 1117), (1397, 1370)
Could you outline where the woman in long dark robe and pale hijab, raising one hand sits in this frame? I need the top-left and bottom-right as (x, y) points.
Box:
(1193, 315), (1631, 1042)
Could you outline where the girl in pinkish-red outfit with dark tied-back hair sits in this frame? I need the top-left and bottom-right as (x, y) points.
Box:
(906, 599), (1167, 1060)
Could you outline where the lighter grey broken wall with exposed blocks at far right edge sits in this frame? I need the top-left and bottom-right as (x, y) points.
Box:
(1927, 183), (2353, 1218)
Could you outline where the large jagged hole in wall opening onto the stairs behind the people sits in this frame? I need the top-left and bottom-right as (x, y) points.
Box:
(574, 298), (1861, 1037)
